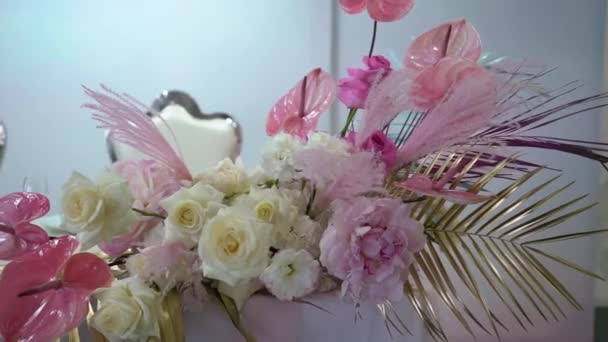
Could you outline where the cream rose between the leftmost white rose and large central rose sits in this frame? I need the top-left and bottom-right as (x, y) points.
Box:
(160, 182), (224, 247)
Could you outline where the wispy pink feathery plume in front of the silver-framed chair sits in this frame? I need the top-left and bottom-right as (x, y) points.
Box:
(83, 85), (192, 180)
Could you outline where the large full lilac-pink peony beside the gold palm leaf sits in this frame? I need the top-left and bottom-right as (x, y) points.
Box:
(320, 197), (426, 303)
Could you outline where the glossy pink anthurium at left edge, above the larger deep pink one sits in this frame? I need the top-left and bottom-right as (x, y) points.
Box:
(0, 192), (50, 260)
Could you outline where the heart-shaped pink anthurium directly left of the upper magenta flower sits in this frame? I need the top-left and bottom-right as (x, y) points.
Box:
(266, 68), (336, 139)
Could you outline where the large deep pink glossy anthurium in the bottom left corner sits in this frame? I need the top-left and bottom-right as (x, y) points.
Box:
(0, 236), (112, 342)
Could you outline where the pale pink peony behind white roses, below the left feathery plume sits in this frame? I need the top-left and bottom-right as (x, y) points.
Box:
(99, 160), (180, 256)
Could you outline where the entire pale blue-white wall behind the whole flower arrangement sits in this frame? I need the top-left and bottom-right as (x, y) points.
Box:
(0, 0), (606, 342)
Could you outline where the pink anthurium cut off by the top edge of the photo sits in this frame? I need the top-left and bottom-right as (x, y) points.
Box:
(338, 0), (414, 22)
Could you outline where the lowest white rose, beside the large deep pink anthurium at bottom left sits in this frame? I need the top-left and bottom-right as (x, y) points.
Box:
(91, 277), (162, 342)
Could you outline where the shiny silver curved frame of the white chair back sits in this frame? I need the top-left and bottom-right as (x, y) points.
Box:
(107, 90), (243, 163)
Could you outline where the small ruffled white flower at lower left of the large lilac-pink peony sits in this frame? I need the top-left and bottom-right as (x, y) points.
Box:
(260, 249), (321, 301)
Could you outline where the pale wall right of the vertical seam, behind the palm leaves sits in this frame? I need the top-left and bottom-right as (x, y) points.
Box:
(336, 0), (606, 342)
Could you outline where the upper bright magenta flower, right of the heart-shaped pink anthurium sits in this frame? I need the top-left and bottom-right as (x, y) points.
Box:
(338, 56), (393, 108)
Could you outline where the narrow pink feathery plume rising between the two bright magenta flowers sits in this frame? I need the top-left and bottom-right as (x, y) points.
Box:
(357, 70), (412, 145)
